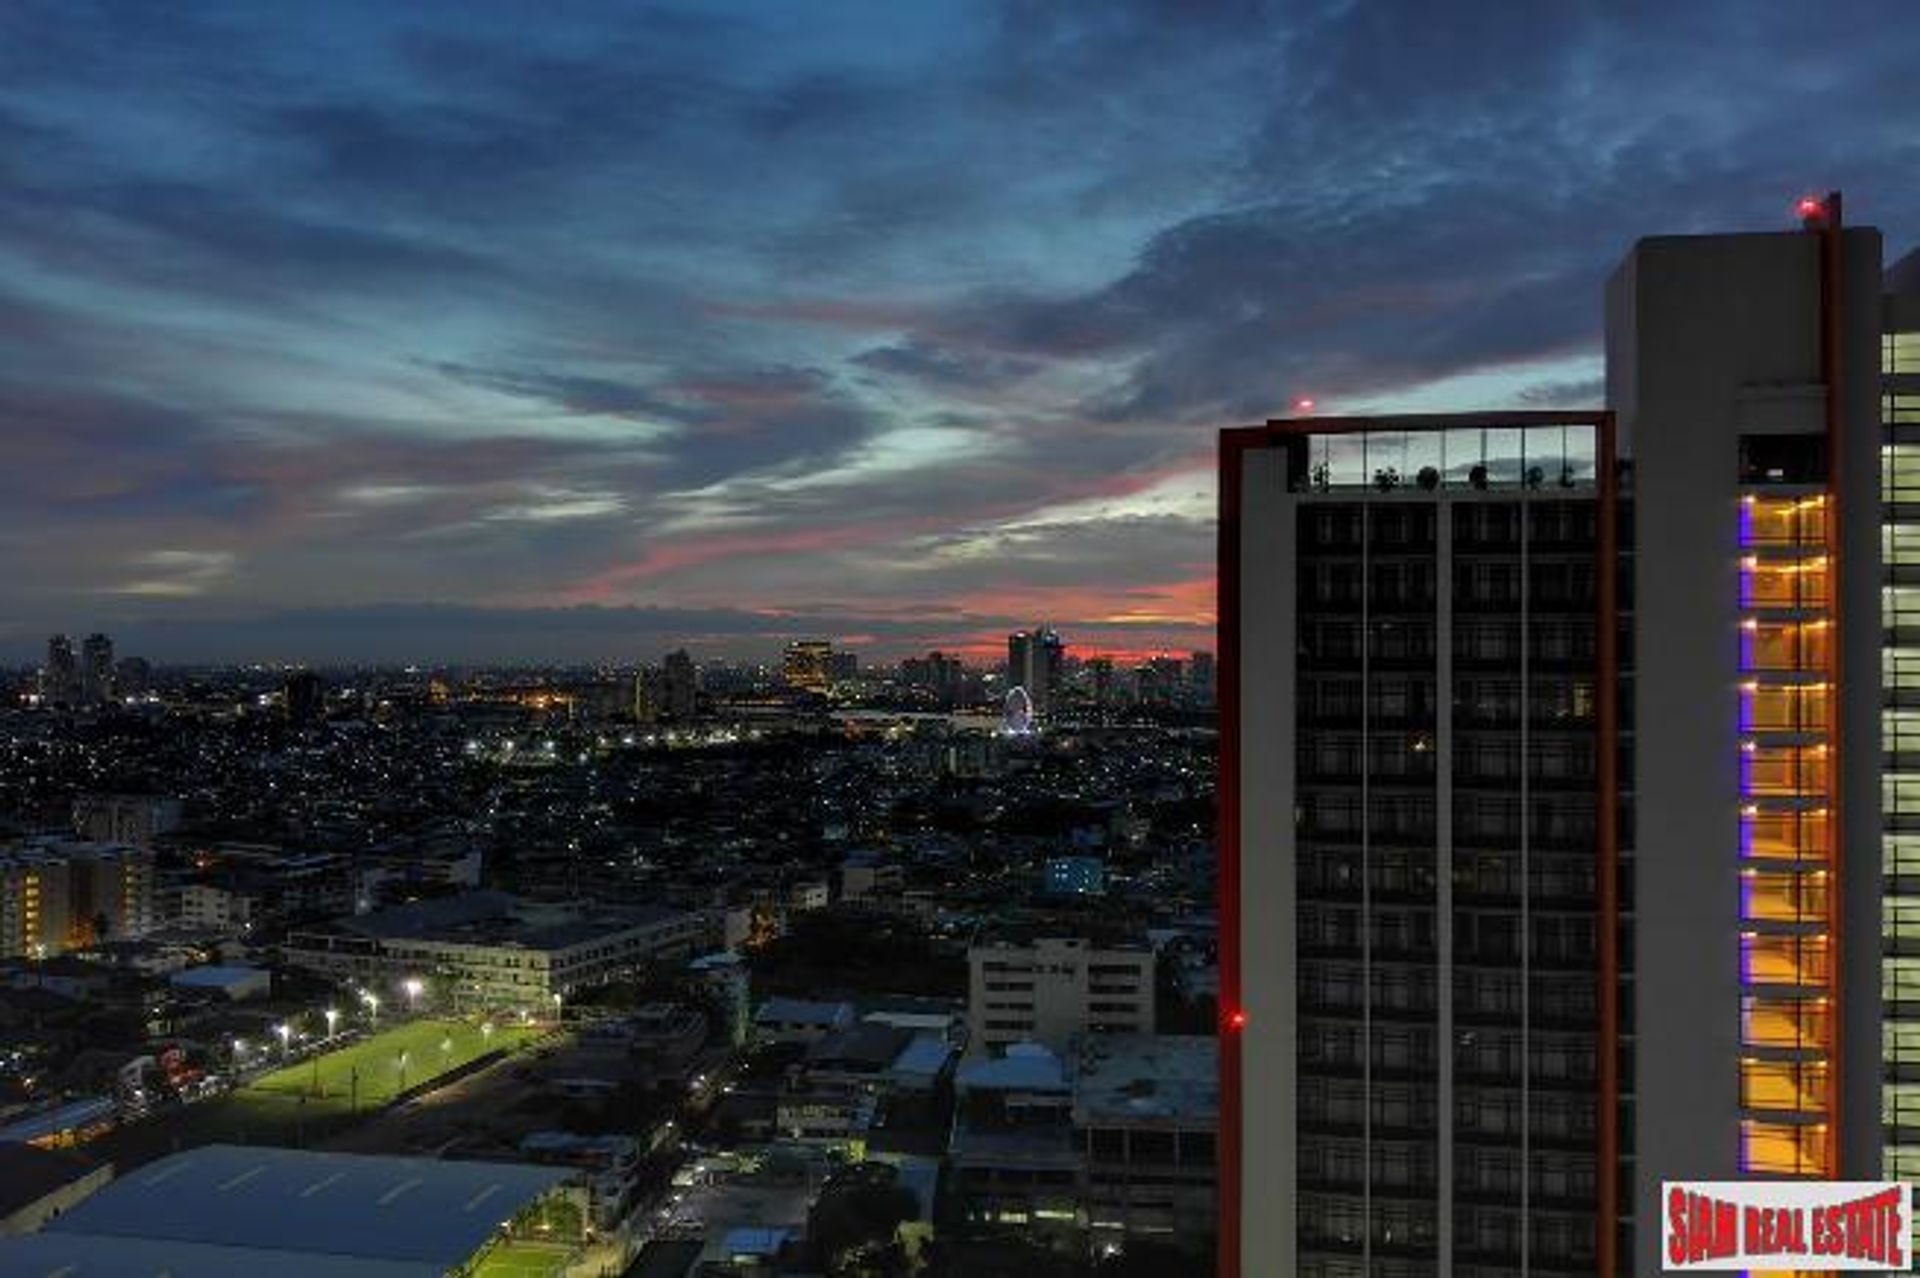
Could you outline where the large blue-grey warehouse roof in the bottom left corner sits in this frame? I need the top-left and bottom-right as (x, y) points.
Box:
(48, 1146), (572, 1274)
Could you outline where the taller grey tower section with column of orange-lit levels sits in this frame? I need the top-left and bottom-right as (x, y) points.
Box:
(1601, 196), (1884, 1272)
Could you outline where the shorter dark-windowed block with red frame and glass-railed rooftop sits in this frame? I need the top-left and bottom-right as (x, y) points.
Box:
(1219, 413), (1620, 1278)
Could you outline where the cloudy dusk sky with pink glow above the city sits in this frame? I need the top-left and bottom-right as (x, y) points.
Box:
(0, 0), (1920, 664)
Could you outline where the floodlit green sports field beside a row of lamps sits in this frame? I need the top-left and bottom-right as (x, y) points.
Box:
(238, 1019), (545, 1117)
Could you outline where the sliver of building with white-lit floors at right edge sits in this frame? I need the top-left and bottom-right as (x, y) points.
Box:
(1880, 251), (1920, 1180)
